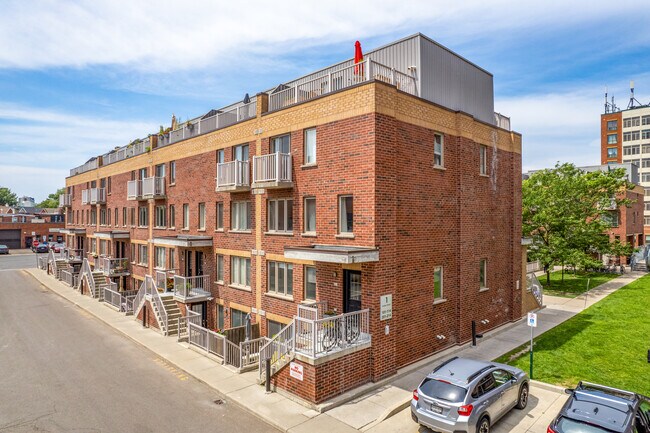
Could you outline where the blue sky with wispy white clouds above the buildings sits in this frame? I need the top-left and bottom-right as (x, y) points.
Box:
(0, 0), (650, 201)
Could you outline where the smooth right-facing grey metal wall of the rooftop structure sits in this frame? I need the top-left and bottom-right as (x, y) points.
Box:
(418, 37), (494, 124)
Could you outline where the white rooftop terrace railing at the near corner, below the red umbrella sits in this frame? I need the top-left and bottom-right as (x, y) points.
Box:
(269, 59), (417, 111)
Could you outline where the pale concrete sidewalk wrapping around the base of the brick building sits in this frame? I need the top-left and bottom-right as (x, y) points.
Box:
(24, 269), (645, 433)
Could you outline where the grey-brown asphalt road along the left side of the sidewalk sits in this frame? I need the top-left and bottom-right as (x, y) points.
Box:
(0, 268), (276, 433)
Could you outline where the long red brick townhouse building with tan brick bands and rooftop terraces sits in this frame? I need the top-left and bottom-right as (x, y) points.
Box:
(61, 34), (523, 402)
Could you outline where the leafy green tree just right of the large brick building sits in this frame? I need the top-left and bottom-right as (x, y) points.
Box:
(522, 164), (634, 284)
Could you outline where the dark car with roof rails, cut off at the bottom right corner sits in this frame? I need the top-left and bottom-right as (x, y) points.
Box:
(547, 382), (650, 433)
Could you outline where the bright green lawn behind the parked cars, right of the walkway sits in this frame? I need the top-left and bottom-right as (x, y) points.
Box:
(497, 275), (650, 395)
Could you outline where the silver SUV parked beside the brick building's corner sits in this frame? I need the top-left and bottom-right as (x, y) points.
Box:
(411, 357), (529, 433)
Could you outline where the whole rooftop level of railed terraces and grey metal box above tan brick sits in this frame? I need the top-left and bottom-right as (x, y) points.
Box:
(70, 33), (510, 176)
